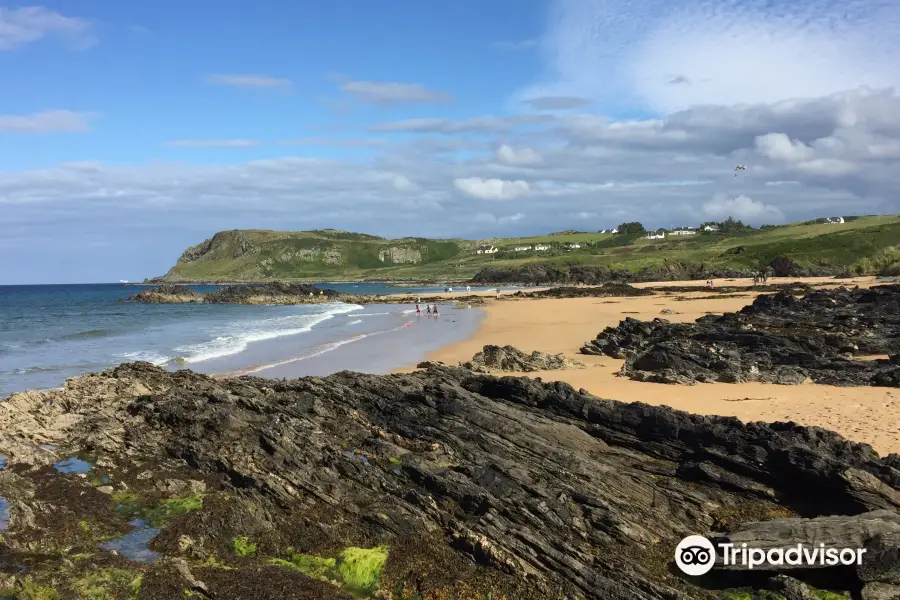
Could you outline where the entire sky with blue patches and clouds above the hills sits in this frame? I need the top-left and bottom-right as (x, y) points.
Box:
(0, 0), (900, 285)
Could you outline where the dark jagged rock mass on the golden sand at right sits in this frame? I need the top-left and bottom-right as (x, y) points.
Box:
(581, 285), (900, 387)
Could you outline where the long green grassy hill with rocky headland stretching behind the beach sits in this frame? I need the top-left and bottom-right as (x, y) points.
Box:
(162, 216), (900, 282)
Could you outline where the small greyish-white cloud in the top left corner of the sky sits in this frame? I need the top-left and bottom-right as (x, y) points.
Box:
(0, 6), (97, 50)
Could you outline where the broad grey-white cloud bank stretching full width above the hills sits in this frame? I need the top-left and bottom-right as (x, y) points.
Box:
(0, 90), (900, 281)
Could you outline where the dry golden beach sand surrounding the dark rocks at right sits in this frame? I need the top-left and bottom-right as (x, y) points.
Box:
(398, 277), (900, 454)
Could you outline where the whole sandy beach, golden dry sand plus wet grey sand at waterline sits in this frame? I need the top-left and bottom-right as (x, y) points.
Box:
(5, 277), (900, 454)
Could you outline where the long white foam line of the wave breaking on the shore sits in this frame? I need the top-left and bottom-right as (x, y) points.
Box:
(175, 304), (363, 363)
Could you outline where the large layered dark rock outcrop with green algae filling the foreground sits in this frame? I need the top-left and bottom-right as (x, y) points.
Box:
(0, 363), (900, 600)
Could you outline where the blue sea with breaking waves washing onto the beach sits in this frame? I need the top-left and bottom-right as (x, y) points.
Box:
(0, 283), (508, 398)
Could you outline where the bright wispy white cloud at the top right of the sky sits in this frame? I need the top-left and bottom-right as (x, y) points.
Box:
(518, 0), (900, 113)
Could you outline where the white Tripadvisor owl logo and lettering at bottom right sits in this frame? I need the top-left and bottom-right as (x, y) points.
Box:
(675, 535), (866, 577)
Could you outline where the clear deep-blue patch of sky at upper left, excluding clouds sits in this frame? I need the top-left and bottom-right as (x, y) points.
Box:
(0, 0), (546, 169)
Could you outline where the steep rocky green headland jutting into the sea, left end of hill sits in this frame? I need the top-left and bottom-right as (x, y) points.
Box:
(164, 230), (461, 281)
